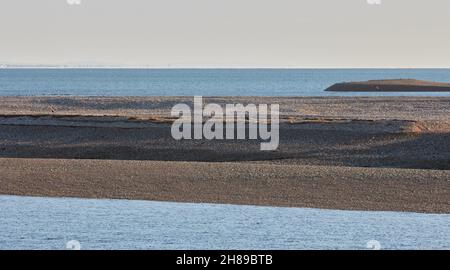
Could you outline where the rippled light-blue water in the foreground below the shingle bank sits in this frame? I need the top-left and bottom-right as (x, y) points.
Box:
(0, 196), (450, 249)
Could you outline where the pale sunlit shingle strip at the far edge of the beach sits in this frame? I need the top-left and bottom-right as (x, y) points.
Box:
(0, 96), (450, 120)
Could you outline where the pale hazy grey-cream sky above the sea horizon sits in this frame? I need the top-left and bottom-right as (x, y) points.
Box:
(0, 0), (450, 67)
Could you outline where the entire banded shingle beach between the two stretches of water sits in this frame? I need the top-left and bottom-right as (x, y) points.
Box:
(0, 97), (450, 213)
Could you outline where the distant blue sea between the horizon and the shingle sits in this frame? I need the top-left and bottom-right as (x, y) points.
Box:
(0, 69), (450, 96)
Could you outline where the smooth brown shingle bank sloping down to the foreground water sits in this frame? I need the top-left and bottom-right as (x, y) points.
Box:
(0, 158), (450, 213)
